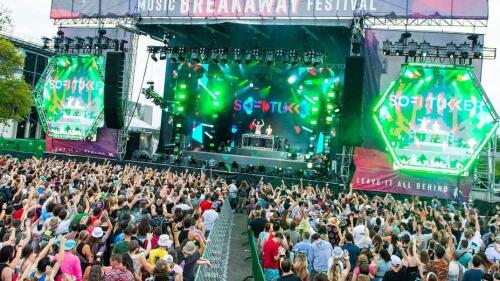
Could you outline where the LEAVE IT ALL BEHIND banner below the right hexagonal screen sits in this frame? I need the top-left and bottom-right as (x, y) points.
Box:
(351, 147), (473, 202)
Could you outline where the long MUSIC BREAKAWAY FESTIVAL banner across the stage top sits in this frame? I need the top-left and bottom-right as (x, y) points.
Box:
(50, 0), (488, 20)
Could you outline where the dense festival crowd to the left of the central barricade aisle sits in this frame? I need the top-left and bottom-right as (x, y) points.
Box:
(0, 156), (223, 281)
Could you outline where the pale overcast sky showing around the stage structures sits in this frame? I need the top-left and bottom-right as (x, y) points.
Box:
(0, 0), (500, 127)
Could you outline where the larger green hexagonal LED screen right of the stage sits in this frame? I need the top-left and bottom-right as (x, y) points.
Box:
(374, 64), (498, 175)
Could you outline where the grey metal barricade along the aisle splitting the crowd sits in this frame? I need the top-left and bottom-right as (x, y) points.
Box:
(195, 197), (234, 281)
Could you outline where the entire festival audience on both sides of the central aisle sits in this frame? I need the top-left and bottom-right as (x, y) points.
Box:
(0, 156), (500, 281)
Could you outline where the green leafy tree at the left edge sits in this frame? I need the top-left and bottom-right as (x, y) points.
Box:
(0, 38), (32, 123)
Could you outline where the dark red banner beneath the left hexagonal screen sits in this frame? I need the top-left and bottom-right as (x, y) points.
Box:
(45, 128), (119, 158)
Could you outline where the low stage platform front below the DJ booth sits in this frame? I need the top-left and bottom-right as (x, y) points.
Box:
(182, 148), (307, 171)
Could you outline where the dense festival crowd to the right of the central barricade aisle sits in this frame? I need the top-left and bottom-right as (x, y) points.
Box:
(246, 181), (500, 281)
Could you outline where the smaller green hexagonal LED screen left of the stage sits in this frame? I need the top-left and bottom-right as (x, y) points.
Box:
(34, 55), (104, 140)
